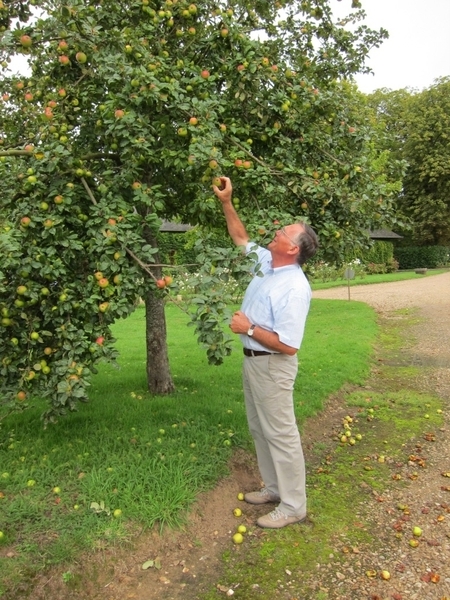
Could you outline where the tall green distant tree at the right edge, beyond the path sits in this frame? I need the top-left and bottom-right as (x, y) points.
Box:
(369, 78), (450, 245)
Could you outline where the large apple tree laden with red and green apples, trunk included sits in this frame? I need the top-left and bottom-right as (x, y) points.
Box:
(0, 0), (392, 419)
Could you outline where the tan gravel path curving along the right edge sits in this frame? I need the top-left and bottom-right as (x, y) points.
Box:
(313, 273), (450, 600)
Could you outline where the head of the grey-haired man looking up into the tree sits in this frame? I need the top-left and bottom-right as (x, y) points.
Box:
(268, 222), (319, 266)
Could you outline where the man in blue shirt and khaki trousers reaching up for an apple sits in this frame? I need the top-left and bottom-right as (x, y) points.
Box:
(213, 177), (319, 529)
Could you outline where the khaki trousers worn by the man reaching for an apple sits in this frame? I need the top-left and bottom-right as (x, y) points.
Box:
(243, 354), (306, 517)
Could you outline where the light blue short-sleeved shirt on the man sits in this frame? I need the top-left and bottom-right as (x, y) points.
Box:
(240, 242), (311, 350)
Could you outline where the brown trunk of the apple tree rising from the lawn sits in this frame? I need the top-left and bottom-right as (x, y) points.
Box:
(144, 228), (175, 394)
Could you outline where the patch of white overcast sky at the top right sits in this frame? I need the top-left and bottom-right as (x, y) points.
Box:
(331, 0), (450, 94)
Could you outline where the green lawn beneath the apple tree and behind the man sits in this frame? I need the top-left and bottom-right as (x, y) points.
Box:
(0, 301), (377, 592)
